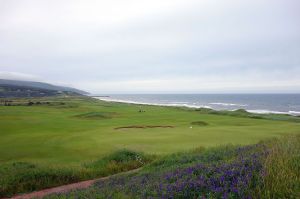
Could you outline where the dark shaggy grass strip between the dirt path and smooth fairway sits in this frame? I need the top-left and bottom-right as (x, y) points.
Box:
(0, 149), (153, 197)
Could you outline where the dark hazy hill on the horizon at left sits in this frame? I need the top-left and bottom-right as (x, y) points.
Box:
(0, 79), (88, 98)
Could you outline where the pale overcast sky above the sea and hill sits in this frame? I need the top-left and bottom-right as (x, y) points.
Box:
(0, 0), (300, 94)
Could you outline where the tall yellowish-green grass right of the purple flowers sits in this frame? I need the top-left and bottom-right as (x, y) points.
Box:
(256, 135), (300, 198)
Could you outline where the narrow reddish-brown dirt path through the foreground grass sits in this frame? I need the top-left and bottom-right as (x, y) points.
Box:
(3, 168), (141, 199)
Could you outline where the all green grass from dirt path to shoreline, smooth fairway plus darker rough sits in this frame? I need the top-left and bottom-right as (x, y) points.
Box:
(0, 97), (300, 196)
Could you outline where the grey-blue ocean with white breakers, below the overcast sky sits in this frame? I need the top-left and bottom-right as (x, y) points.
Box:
(95, 94), (300, 116)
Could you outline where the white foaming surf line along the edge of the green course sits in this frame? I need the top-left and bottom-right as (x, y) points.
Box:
(92, 96), (300, 117)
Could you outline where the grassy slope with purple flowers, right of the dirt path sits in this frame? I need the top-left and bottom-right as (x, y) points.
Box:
(47, 135), (300, 199)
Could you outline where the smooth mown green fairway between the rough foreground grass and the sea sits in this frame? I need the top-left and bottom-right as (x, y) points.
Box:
(0, 97), (300, 165)
